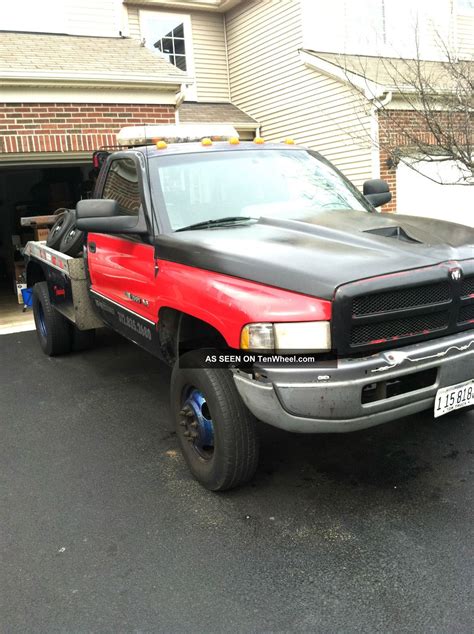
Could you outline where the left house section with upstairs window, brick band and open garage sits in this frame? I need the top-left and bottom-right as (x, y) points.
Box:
(0, 0), (258, 302)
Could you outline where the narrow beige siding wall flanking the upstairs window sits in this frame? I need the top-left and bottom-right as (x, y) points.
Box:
(128, 6), (229, 102)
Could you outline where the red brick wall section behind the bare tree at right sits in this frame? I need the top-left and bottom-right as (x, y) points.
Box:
(378, 110), (472, 212)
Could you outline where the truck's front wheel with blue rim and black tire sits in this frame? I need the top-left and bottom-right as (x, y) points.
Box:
(171, 352), (258, 491)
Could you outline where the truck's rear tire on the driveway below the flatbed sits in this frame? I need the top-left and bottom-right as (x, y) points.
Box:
(33, 282), (71, 357)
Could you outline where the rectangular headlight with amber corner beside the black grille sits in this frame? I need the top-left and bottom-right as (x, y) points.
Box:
(240, 321), (331, 352)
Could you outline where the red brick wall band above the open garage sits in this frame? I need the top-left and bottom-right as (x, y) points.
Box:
(0, 103), (175, 154)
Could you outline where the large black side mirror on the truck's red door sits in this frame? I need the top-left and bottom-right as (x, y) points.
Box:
(76, 198), (148, 234)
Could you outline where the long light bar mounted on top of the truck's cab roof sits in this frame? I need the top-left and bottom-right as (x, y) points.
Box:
(117, 124), (239, 147)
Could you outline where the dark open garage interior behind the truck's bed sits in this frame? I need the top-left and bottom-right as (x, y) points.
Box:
(0, 157), (94, 334)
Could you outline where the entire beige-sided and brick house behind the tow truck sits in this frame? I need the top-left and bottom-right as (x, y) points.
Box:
(0, 0), (474, 304)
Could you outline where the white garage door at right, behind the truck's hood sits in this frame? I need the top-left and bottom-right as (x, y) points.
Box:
(397, 161), (474, 227)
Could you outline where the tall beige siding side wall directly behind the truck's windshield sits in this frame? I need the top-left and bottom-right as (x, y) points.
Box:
(226, 0), (372, 186)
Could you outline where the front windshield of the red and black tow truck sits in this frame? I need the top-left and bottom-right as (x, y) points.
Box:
(150, 149), (370, 231)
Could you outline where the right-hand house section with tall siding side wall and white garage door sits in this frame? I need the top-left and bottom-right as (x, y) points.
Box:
(225, 0), (474, 222)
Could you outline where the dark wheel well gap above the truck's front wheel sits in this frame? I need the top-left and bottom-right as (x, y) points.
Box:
(158, 308), (227, 364)
